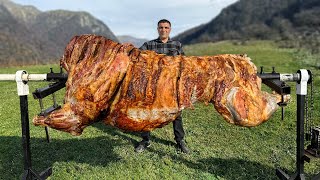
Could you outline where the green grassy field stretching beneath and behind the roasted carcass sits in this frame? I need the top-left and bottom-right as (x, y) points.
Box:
(0, 41), (320, 180)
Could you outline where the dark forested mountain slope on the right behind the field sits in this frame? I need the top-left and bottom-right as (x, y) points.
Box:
(174, 0), (320, 52)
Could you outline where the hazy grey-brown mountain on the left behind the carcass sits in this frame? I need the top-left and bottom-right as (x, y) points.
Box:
(0, 0), (119, 66)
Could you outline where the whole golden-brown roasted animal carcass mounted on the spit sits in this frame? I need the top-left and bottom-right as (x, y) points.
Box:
(33, 35), (281, 135)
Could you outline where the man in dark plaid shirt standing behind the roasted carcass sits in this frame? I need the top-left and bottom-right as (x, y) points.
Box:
(135, 19), (189, 153)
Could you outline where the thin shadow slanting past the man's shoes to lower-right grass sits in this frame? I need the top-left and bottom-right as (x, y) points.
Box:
(93, 123), (284, 180)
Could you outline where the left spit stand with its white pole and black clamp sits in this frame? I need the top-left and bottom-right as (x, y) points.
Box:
(0, 69), (68, 180)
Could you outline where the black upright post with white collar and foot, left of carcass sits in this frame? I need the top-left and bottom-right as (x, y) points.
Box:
(16, 71), (52, 180)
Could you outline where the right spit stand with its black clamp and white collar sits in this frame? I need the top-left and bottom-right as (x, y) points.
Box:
(258, 68), (320, 180)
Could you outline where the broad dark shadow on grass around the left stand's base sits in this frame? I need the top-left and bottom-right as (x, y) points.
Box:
(0, 132), (123, 179)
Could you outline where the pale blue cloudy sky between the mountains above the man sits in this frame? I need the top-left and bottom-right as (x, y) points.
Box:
(12, 0), (237, 39)
